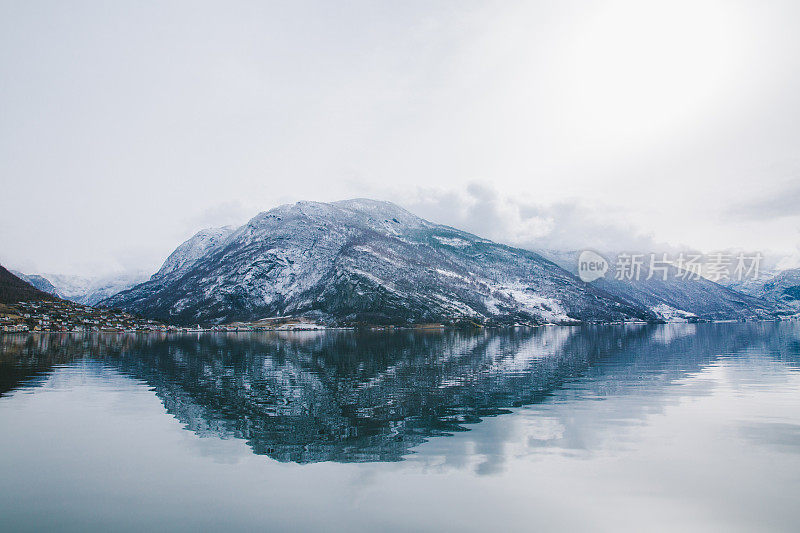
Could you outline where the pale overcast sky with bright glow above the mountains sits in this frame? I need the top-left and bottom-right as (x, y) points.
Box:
(0, 0), (800, 274)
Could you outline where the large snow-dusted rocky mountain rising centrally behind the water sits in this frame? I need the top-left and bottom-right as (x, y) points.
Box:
(102, 199), (657, 324)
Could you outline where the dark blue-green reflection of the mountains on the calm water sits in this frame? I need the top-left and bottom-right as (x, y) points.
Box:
(0, 323), (800, 463)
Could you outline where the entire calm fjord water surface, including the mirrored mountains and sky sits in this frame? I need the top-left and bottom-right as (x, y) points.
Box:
(0, 322), (800, 531)
